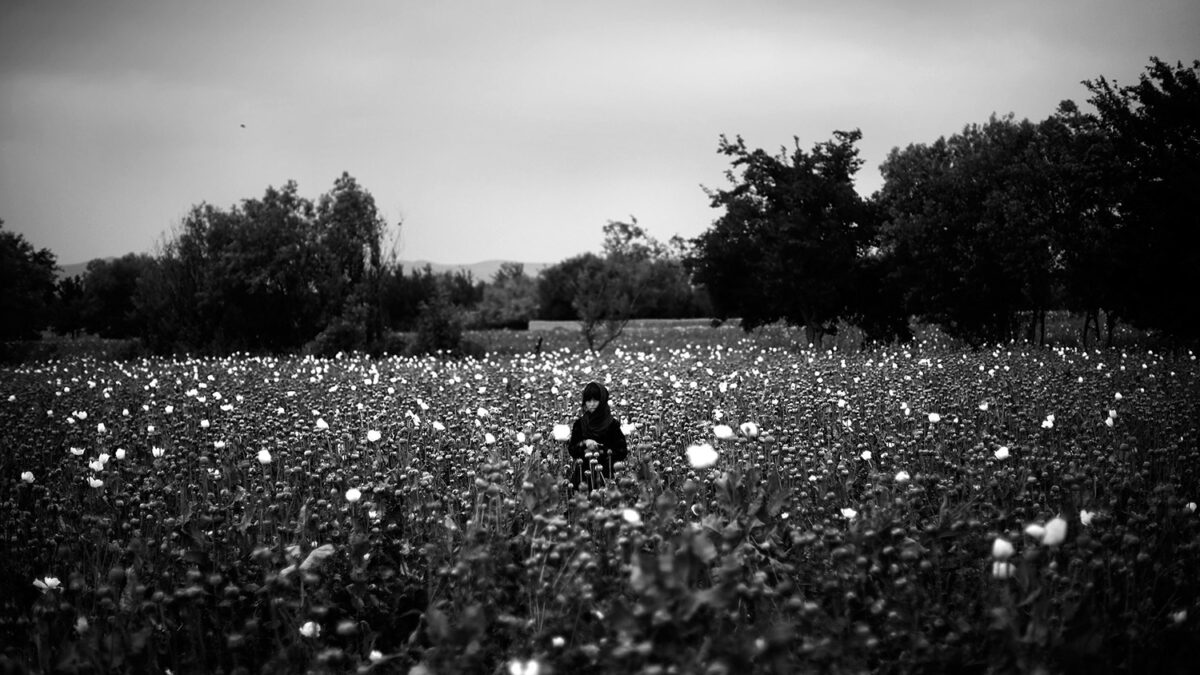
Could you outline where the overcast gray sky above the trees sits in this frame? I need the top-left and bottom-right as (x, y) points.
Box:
(0, 0), (1200, 264)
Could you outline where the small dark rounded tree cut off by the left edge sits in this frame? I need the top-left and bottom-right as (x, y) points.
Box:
(0, 220), (58, 340)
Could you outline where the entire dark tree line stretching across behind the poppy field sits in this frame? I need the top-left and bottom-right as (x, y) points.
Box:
(0, 59), (1200, 353)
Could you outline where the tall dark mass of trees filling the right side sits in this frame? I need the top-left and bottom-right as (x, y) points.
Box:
(690, 59), (1200, 346)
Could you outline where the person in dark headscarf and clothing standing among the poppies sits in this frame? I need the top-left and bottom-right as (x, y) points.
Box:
(566, 382), (629, 490)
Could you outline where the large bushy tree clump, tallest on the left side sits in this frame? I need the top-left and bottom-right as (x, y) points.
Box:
(137, 174), (383, 352)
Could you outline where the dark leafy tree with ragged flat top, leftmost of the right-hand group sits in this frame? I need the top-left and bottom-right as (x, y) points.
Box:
(688, 130), (874, 342)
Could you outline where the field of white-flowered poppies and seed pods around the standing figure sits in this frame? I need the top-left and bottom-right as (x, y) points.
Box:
(0, 333), (1200, 675)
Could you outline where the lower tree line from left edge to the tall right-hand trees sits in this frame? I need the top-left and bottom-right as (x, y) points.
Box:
(0, 173), (708, 354)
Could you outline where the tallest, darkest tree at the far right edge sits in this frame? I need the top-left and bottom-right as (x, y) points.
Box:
(1085, 59), (1200, 339)
